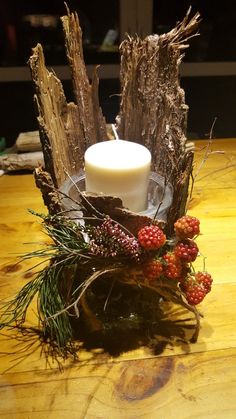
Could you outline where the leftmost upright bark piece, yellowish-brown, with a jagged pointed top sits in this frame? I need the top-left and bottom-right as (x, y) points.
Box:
(29, 44), (84, 187)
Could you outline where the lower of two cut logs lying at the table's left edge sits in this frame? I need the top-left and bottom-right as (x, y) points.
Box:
(0, 151), (44, 172)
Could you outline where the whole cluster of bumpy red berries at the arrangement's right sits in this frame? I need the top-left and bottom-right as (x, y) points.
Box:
(138, 215), (212, 305)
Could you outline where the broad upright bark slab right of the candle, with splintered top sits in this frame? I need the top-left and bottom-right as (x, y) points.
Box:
(116, 10), (199, 233)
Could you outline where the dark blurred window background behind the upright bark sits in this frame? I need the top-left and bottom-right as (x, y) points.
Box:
(0, 0), (236, 146)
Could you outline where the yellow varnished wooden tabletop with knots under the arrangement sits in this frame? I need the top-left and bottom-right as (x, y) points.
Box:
(0, 139), (236, 419)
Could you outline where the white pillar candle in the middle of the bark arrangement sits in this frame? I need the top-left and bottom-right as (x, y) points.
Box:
(84, 140), (151, 212)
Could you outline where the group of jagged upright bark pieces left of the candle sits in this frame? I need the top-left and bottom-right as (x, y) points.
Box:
(29, 11), (108, 192)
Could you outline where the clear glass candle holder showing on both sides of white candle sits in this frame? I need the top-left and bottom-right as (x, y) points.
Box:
(60, 172), (173, 221)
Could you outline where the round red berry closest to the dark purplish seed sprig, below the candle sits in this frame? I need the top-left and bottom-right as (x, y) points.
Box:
(138, 225), (166, 250)
